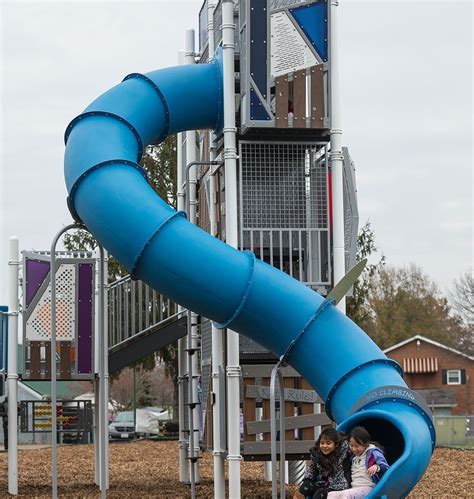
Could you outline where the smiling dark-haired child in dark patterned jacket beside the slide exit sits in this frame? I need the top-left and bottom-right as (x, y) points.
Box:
(294, 428), (351, 499)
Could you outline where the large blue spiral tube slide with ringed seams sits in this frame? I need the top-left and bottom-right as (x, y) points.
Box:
(65, 57), (435, 498)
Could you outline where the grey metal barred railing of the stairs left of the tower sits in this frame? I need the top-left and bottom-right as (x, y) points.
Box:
(108, 276), (179, 349)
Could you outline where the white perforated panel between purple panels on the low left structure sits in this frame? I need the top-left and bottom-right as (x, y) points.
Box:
(26, 264), (76, 341)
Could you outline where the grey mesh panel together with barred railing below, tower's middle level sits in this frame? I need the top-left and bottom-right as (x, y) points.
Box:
(240, 141), (330, 286)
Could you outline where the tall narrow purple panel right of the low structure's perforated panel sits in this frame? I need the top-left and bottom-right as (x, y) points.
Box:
(77, 263), (94, 374)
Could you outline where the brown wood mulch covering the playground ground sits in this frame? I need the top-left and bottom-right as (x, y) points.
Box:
(0, 440), (474, 499)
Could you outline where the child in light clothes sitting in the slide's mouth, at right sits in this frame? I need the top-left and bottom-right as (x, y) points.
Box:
(328, 426), (388, 499)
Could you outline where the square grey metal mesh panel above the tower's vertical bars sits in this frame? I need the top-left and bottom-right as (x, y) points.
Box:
(241, 142), (327, 229)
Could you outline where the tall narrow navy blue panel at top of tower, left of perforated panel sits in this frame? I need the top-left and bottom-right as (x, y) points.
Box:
(249, 0), (268, 100)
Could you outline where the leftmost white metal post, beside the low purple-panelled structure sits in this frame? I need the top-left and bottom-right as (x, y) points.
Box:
(5, 236), (20, 496)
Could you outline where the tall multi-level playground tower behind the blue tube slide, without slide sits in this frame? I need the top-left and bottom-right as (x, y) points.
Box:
(183, 0), (358, 497)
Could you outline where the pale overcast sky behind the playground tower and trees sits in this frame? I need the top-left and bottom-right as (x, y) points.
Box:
(0, 0), (473, 303)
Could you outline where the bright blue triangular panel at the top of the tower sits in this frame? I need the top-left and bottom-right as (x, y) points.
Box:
(290, 0), (328, 62)
